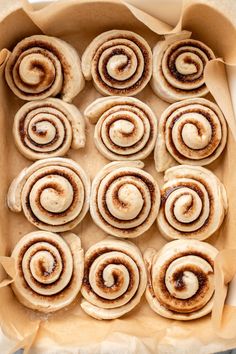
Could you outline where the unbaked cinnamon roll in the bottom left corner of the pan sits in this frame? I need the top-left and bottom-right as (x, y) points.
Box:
(11, 231), (84, 313)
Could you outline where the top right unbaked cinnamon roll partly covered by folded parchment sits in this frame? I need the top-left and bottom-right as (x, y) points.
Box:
(151, 31), (215, 103)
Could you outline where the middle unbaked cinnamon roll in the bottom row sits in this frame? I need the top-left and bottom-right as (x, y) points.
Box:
(81, 238), (147, 320)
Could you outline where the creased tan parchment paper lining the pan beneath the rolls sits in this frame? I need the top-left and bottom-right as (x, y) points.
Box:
(0, 0), (236, 354)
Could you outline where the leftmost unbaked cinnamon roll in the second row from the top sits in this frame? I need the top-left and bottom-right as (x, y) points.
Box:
(13, 98), (85, 160)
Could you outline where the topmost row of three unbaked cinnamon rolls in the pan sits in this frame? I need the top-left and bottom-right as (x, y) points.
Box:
(5, 30), (215, 103)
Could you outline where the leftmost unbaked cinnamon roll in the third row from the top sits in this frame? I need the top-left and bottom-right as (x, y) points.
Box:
(7, 157), (90, 232)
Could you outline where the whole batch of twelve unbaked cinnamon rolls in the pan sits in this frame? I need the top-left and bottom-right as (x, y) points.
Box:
(5, 30), (227, 320)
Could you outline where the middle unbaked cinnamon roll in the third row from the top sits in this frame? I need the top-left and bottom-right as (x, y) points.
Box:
(90, 161), (160, 238)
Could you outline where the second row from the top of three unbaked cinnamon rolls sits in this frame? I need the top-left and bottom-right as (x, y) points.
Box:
(8, 96), (227, 172)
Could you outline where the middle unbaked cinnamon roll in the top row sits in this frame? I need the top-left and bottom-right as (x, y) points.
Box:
(82, 30), (152, 96)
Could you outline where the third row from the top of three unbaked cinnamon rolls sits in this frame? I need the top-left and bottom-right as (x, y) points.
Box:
(7, 157), (227, 240)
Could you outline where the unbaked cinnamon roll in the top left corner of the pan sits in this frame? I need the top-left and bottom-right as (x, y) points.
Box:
(5, 35), (84, 102)
